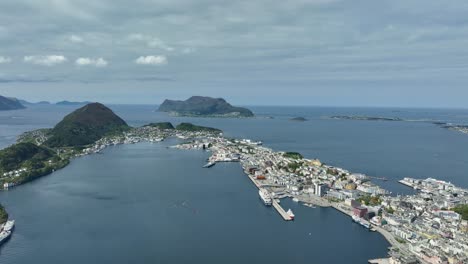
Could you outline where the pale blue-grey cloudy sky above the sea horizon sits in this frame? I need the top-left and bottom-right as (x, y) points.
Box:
(0, 0), (468, 108)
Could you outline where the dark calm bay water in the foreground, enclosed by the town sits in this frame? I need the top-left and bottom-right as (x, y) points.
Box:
(0, 140), (388, 263)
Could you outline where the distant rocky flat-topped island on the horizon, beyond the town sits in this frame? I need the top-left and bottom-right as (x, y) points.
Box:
(158, 96), (254, 117)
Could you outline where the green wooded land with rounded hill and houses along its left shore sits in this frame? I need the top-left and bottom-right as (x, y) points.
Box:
(0, 103), (222, 189)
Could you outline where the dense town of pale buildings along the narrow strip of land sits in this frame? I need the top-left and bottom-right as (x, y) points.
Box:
(3, 126), (468, 264)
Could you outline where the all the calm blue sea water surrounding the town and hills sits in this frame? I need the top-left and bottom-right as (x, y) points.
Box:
(0, 106), (468, 263)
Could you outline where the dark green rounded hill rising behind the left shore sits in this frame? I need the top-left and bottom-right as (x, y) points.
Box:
(45, 103), (129, 147)
